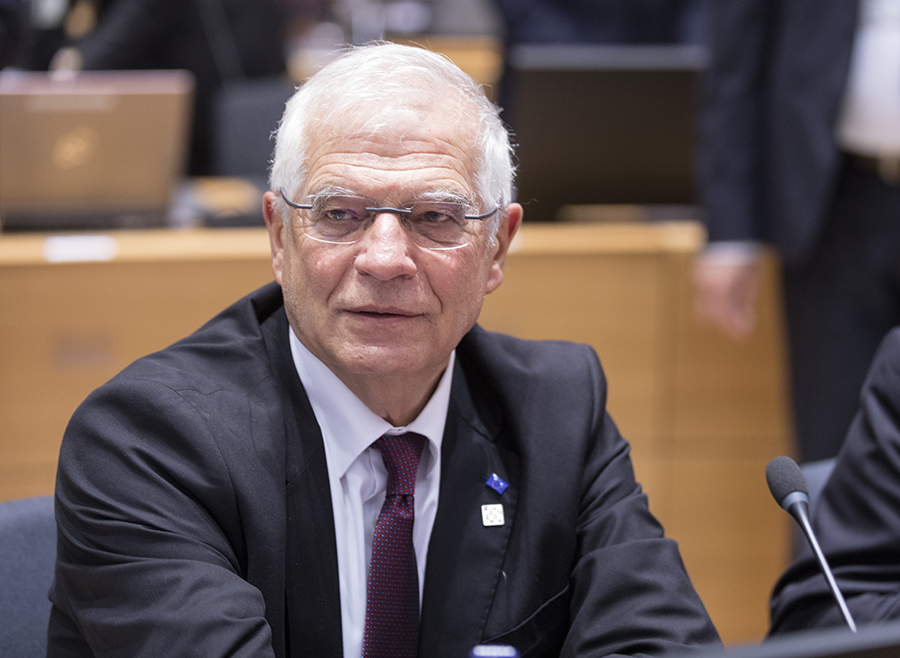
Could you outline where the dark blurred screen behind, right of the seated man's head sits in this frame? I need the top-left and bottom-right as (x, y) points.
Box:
(504, 45), (706, 221)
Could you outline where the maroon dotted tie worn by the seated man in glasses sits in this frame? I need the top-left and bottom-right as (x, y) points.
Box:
(362, 433), (425, 658)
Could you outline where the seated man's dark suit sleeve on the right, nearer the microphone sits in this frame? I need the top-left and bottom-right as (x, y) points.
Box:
(561, 346), (719, 656)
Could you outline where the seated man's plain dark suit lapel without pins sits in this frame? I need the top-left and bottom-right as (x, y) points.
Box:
(266, 312), (343, 658)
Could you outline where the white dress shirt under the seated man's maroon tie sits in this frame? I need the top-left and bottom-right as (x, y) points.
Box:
(290, 330), (456, 658)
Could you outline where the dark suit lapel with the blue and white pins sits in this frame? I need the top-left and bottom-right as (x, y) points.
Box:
(419, 358), (519, 658)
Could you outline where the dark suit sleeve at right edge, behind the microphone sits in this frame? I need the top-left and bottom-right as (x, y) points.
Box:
(772, 328), (900, 633)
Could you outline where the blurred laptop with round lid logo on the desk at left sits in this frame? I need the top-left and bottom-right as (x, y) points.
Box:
(0, 71), (194, 231)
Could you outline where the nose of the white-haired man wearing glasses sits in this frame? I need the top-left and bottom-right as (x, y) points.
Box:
(356, 211), (416, 281)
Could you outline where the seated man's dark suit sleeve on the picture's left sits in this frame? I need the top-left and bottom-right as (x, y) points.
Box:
(48, 377), (274, 658)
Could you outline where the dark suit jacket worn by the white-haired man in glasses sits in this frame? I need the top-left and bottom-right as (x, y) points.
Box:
(49, 284), (718, 658)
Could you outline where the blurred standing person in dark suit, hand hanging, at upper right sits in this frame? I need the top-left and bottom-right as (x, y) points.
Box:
(695, 0), (900, 462)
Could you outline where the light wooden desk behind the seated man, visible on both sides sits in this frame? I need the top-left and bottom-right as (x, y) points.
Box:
(0, 223), (789, 643)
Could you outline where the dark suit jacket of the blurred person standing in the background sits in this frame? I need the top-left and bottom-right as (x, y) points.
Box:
(698, 0), (857, 263)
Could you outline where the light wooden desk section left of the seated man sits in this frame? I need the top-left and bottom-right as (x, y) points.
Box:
(0, 229), (272, 500)
